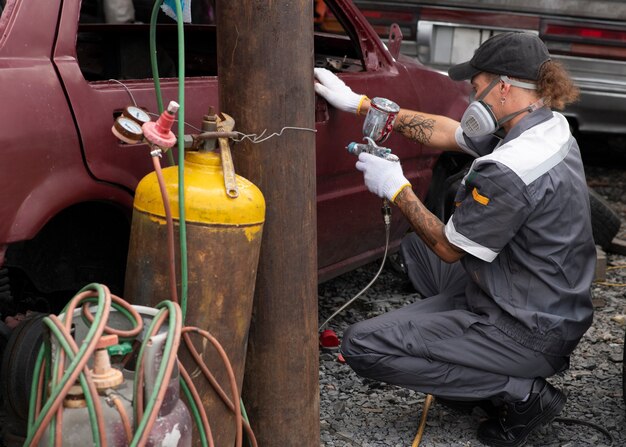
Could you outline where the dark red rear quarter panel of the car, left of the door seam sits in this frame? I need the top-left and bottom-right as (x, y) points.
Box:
(0, 0), (90, 247)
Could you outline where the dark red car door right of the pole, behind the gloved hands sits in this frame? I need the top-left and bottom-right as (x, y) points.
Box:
(315, 0), (434, 280)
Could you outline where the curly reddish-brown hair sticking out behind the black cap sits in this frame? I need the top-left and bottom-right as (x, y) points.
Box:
(537, 60), (580, 110)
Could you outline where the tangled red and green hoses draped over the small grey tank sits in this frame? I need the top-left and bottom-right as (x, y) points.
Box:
(24, 284), (257, 447)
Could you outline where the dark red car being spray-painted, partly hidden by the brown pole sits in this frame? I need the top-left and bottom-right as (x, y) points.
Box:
(0, 0), (467, 320)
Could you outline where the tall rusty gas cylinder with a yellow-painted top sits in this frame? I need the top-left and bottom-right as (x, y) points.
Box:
(124, 151), (265, 445)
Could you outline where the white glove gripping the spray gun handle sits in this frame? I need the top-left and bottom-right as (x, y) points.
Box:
(356, 152), (411, 202)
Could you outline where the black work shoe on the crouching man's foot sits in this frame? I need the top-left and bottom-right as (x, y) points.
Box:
(478, 378), (566, 447)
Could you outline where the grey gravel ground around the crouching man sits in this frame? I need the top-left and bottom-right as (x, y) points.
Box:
(319, 168), (626, 447)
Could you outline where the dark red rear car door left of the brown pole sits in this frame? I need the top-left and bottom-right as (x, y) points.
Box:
(54, 0), (218, 191)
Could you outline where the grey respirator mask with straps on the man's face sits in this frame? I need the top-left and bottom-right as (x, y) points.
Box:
(461, 76), (543, 138)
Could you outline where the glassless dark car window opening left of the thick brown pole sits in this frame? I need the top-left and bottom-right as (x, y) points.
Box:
(76, 0), (217, 81)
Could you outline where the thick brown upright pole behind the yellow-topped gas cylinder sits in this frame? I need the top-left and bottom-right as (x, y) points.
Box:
(216, 0), (320, 447)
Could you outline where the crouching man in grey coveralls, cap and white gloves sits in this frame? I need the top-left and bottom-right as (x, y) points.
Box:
(315, 33), (596, 446)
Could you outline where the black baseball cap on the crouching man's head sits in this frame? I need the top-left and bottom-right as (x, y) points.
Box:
(448, 32), (550, 81)
